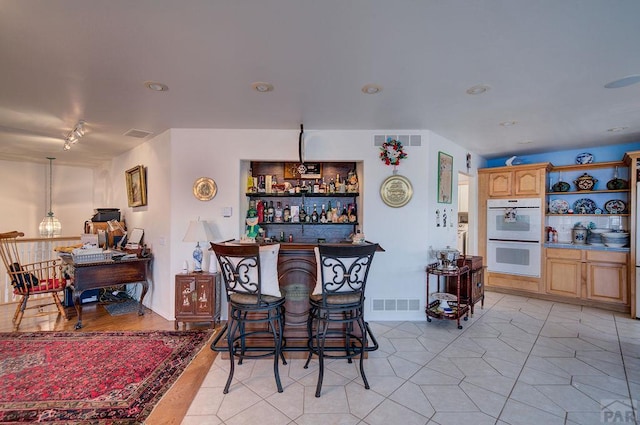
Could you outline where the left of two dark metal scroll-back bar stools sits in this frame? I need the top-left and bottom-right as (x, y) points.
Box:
(211, 243), (287, 394)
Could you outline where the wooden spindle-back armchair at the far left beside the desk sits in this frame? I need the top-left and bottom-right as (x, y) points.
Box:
(0, 230), (67, 331)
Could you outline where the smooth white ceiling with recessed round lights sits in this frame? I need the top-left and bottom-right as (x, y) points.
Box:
(0, 0), (640, 166)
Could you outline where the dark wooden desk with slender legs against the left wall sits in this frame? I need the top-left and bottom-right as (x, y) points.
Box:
(63, 257), (151, 329)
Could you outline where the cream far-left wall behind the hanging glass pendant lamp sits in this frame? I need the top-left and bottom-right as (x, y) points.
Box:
(0, 160), (94, 238)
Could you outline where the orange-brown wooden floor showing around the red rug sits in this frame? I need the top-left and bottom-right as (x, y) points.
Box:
(0, 303), (215, 425)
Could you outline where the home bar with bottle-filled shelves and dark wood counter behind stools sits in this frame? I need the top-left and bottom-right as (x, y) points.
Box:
(220, 161), (382, 357)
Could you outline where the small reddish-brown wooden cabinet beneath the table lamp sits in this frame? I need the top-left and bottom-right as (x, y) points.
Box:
(175, 272), (221, 330)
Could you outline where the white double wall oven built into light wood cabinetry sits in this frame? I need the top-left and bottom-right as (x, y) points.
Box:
(487, 198), (542, 277)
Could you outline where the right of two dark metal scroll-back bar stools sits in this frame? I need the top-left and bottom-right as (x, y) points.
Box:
(304, 244), (378, 397)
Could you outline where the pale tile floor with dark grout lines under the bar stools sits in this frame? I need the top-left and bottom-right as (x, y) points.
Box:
(182, 292), (640, 425)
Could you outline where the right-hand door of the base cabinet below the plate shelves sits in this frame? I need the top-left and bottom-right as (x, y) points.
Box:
(587, 262), (629, 304)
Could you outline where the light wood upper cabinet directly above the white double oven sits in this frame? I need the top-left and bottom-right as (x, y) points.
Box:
(478, 162), (551, 198)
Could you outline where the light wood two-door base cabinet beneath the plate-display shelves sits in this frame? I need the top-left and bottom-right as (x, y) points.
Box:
(545, 248), (629, 306)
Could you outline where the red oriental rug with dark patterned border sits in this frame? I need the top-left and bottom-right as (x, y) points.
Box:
(0, 330), (213, 425)
